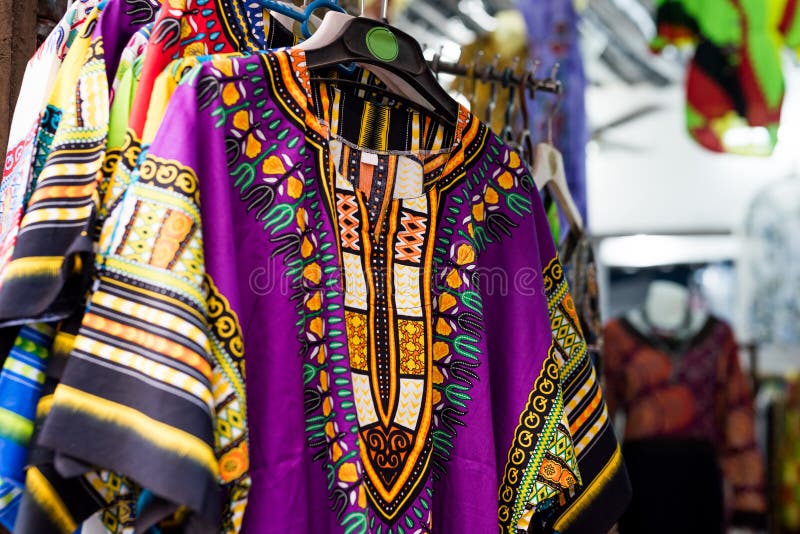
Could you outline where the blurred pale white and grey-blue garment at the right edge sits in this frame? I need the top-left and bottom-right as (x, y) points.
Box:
(738, 178), (800, 346)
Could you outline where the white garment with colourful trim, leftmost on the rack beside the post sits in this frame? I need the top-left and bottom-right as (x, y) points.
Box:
(0, 0), (97, 296)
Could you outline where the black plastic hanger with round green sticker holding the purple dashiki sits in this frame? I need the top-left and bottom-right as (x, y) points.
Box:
(299, 12), (459, 124)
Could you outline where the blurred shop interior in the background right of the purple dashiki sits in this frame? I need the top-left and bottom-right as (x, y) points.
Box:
(3, 0), (800, 534)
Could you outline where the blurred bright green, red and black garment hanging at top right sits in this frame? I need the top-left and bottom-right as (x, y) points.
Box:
(653, 0), (800, 155)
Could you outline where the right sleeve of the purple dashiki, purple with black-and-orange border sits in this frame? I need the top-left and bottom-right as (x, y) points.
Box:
(466, 152), (630, 532)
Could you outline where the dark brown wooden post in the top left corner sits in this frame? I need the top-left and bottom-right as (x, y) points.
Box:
(0, 0), (36, 154)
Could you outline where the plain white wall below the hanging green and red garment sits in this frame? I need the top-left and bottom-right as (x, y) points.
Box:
(587, 57), (800, 236)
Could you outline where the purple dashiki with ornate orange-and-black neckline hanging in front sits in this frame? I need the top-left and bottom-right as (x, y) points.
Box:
(34, 50), (620, 532)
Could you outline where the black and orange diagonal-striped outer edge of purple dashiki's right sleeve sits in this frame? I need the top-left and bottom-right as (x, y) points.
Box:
(529, 202), (632, 534)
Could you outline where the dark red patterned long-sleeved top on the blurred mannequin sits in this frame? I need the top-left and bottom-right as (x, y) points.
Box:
(604, 317), (766, 526)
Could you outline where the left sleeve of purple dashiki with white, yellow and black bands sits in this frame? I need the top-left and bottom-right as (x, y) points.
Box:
(40, 63), (250, 533)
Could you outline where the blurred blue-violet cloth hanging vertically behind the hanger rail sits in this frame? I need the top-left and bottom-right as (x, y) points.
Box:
(516, 0), (589, 224)
